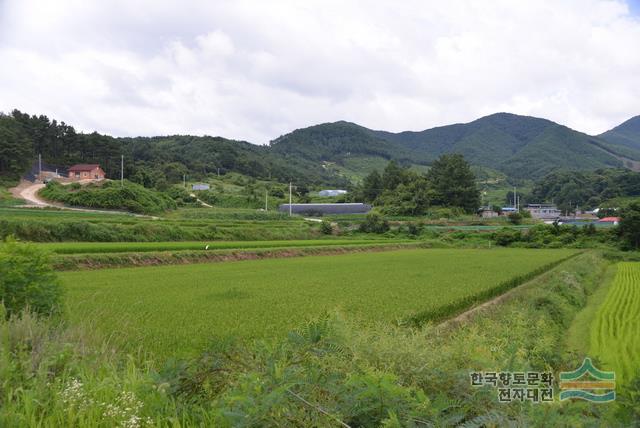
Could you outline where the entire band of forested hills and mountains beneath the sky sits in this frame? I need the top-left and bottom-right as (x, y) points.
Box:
(0, 110), (640, 187)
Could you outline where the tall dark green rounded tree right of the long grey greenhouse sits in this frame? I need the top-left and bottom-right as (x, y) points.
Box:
(427, 154), (480, 212)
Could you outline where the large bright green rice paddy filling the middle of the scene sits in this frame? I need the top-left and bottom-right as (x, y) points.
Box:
(60, 249), (574, 356)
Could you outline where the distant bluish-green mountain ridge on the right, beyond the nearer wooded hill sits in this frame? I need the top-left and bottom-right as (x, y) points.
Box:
(271, 113), (640, 179)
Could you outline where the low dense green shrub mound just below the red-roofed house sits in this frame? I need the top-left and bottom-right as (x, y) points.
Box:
(40, 181), (176, 214)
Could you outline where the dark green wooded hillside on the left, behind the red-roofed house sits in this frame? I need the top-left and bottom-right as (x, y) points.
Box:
(0, 110), (345, 187)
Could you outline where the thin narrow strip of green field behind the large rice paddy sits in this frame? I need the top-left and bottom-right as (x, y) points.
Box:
(30, 238), (415, 254)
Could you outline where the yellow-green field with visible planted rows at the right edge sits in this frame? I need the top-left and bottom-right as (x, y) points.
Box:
(591, 262), (640, 383)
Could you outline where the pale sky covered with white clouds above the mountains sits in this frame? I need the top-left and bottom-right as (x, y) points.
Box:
(0, 0), (640, 144)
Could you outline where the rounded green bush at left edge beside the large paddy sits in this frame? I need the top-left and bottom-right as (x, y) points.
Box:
(0, 240), (62, 317)
